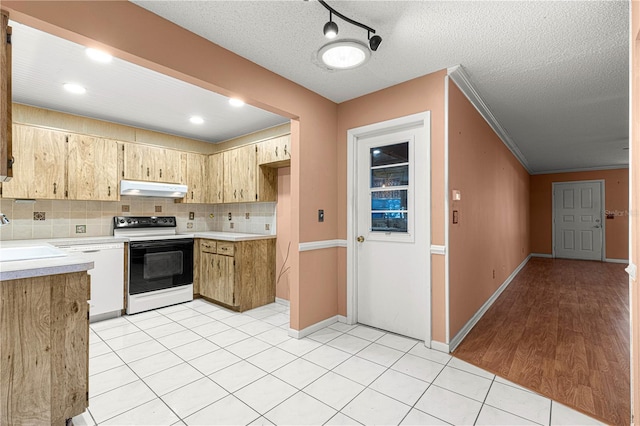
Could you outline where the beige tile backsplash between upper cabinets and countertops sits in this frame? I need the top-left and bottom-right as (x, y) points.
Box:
(0, 196), (276, 240)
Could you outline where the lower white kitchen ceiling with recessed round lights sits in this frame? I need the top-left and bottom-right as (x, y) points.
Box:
(11, 22), (289, 142)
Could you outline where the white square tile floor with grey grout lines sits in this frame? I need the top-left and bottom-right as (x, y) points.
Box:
(74, 300), (600, 425)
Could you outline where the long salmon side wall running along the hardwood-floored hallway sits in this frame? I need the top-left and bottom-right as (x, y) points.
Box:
(448, 82), (529, 338)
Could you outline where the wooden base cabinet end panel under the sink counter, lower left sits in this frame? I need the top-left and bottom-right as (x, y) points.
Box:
(0, 271), (90, 425)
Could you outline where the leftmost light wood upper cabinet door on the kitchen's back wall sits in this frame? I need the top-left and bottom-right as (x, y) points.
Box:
(2, 124), (67, 199)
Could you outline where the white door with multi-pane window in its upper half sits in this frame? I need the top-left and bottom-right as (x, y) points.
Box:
(354, 117), (431, 343)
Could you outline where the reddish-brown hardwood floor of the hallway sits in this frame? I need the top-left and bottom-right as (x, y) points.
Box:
(453, 258), (630, 425)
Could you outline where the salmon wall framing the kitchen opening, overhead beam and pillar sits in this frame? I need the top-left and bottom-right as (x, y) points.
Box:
(2, 0), (338, 329)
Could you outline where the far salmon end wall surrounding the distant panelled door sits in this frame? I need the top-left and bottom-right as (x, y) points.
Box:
(531, 169), (629, 259)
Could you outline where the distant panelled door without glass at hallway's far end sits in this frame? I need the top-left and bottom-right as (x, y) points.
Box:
(553, 181), (604, 260)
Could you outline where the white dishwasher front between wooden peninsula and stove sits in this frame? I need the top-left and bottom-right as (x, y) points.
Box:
(57, 243), (124, 321)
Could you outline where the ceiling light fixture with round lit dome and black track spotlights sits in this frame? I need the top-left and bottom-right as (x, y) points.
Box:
(318, 0), (382, 69)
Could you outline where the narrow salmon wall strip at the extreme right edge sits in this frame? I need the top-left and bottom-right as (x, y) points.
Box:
(629, 0), (640, 424)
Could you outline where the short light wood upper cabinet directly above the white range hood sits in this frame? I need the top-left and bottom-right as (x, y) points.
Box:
(122, 142), (183, 183)
